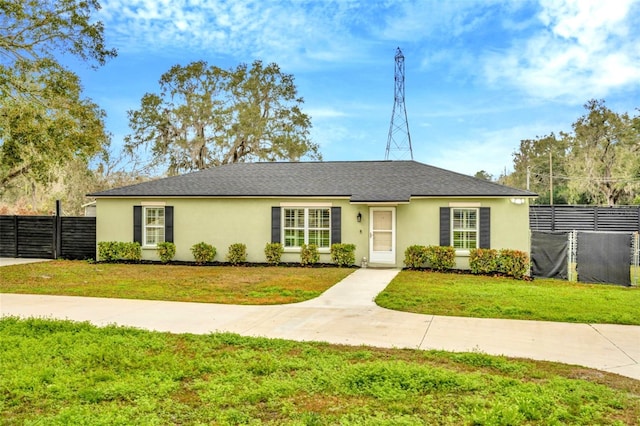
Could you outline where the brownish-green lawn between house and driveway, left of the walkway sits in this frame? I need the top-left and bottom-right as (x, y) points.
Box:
(0, 260), (353, 305)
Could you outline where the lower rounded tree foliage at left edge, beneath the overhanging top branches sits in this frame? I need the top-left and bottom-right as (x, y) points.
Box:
(0, 62), (108, 192)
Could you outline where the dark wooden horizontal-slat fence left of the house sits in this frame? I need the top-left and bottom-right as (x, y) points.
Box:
(0, 216), (96, 259)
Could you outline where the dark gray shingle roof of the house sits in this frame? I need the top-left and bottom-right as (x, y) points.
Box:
(90, 161), (536, 202)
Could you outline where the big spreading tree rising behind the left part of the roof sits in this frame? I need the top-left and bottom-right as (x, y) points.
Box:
(125, 61), (321, 174)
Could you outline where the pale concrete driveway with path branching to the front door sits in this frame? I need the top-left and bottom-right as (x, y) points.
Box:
(0, 269), (640, 380)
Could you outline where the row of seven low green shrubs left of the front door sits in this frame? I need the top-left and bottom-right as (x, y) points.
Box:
(98, 241), (356, 267)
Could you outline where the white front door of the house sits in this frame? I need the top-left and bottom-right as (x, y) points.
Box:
(369, 207), (396, 264)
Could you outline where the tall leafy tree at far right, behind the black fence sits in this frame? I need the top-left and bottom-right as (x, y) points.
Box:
(568, 99), (640, 206)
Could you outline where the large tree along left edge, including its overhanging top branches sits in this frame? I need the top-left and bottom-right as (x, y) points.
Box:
(0, 0), (116, 193)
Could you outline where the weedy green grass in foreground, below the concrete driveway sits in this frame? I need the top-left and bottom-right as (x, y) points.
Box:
(0, 318), (640, 425)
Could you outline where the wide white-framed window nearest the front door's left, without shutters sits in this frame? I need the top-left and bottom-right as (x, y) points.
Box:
(282, 207), (331, 248)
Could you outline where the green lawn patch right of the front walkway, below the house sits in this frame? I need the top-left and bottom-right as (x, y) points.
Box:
(376, 270), (640, 325)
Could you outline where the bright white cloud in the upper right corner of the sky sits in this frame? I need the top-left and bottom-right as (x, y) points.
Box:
(484, 0), (640, 102)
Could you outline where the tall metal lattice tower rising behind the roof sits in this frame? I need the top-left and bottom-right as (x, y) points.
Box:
(384, 47), (413, 160)
